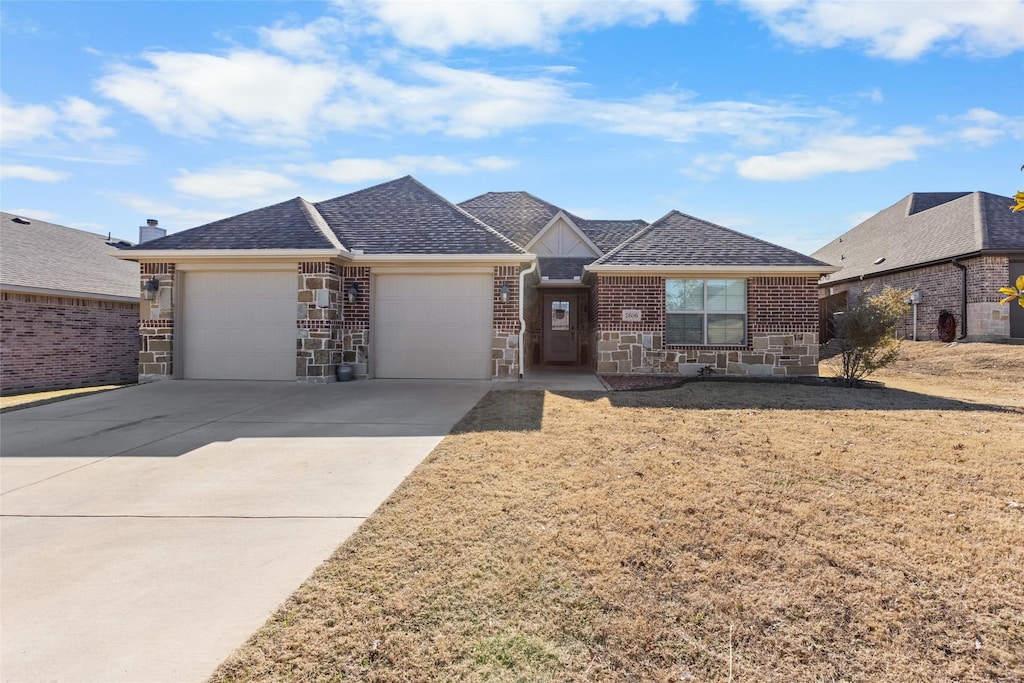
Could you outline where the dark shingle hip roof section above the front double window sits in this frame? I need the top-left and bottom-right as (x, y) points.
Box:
(595, 211), (827, 268)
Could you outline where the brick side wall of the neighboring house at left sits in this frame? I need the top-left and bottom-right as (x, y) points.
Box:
(0, 292), (138, 395)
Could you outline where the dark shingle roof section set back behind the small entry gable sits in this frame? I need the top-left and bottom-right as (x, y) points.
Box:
(459, 191), (647, 252)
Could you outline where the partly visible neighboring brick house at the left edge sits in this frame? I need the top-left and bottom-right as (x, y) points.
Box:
(0, 213), (139, 394)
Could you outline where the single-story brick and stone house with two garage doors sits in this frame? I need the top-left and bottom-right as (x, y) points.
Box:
(119, 176), (834, 382)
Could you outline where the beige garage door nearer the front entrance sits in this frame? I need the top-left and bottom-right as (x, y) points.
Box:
(372, 274), (493, 379)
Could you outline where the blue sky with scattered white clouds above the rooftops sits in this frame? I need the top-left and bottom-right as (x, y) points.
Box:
(0, 0), (1024, 253)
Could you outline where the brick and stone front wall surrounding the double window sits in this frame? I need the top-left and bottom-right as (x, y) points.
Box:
(593, 275), (818, 377)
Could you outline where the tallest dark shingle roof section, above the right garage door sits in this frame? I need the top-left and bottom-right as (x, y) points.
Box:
(315, 176), (524, 254)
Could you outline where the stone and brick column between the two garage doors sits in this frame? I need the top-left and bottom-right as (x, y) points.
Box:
(295, 262), (341, 383)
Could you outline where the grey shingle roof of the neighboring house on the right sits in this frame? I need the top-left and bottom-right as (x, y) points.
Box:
(813, 193), (1024, 283)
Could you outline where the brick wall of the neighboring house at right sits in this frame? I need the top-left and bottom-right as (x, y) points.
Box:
(819, 256), (1010, 340)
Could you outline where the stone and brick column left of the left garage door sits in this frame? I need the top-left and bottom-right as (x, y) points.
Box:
(138, 263), (175, 382)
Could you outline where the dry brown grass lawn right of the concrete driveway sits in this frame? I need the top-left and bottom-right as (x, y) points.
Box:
(213, 343), (1024, 681)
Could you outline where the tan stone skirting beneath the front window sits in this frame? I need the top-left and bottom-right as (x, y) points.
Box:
(595, 330), (818, 377)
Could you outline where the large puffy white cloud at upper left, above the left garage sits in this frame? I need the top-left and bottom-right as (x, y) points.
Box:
(96, 50), (340, 143)
